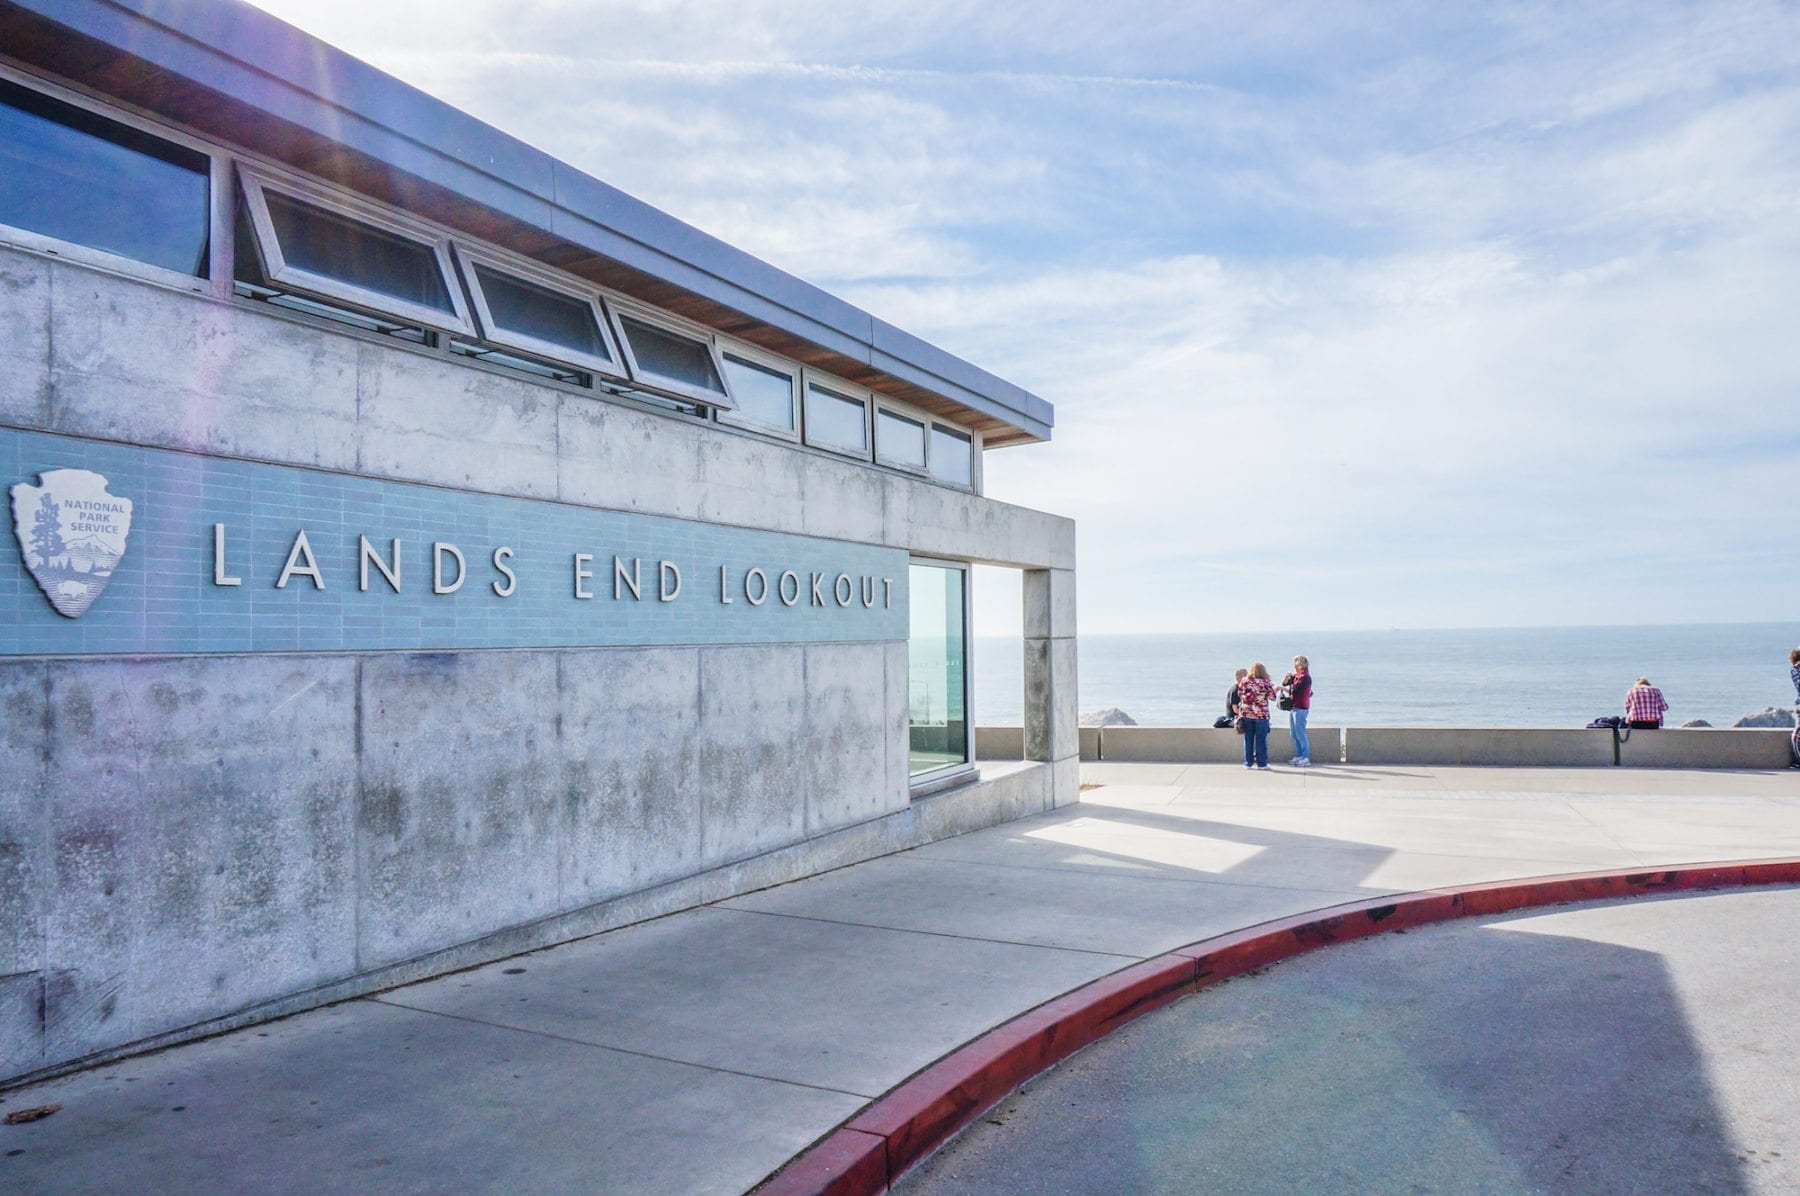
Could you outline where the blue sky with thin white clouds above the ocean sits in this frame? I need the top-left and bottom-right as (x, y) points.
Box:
(246, 0), (1800, 632)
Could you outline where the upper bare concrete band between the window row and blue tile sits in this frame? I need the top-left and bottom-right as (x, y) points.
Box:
(0, 247), (1075, 572)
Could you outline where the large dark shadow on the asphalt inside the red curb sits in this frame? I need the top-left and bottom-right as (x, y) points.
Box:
(896, 907), (1756, 1194)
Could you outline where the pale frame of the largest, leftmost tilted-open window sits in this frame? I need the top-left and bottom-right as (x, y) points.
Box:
(238, 159), (481, 337)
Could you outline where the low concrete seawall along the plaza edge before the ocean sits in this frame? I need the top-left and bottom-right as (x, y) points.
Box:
(976, 726), (1791, 769)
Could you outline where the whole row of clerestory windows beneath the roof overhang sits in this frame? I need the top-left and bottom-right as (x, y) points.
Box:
(0, 67), (979, 490)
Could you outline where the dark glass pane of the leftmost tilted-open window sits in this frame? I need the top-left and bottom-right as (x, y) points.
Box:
(263, 191), (455, 315)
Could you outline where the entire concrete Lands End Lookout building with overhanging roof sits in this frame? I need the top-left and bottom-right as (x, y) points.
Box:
(0, 0), (1078, 1083)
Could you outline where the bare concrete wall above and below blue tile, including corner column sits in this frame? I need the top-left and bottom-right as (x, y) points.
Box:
(0, 249), (1078, 1081)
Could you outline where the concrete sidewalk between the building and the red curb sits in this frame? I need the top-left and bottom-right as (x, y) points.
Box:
(0, 764), (1800, 1192)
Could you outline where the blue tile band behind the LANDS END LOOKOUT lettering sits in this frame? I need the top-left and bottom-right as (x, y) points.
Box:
(0, 429), (907, 656)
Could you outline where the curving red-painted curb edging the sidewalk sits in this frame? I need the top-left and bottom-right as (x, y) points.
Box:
(756, 859), (1800, 1196)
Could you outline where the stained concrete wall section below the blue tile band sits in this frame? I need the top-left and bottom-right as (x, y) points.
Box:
(0, 643), (900, 1075)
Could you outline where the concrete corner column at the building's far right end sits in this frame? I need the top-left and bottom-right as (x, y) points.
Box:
(1024, 569), (1082, 805)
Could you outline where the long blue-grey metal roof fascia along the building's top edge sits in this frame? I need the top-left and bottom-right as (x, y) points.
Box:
(14, 0), (1051, 439)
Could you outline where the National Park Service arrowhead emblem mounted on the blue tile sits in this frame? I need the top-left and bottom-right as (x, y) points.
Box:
(13, 470), (131, 620)
